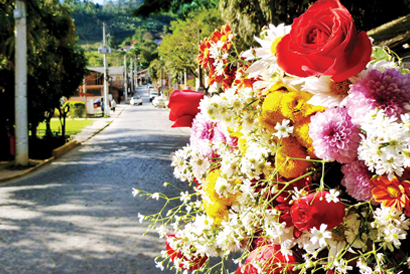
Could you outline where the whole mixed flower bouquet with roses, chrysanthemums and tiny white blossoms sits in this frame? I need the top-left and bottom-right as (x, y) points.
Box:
(133, 0), (410, 274)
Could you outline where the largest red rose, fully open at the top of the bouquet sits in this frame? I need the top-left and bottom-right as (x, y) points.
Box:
(276, 0), (372, 82)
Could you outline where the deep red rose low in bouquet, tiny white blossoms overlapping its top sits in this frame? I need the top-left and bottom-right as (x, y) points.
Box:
(290, 191), (345, 231)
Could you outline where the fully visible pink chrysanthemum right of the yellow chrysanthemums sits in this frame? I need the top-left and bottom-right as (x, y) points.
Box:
(309, 108), (360, 163)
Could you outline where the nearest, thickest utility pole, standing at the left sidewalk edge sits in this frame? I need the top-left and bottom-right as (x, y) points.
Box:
(14, 0), (29, 166)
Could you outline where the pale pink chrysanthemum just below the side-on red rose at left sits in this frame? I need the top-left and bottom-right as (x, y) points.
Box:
(190, 113), (226, 155)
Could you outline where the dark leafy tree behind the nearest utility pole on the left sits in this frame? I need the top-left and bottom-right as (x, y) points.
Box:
(0, 0), (86, 158)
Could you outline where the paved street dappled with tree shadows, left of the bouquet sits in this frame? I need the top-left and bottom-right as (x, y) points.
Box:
(0, 86), (189, 274)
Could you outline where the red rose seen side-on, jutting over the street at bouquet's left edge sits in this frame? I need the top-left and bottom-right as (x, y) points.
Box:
(168, 90), (204, 127)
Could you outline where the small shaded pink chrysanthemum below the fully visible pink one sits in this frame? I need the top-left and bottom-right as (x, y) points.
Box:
(342, 160), (372, 201)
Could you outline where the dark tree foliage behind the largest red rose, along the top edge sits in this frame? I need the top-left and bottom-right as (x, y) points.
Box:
(220, 0), (410, 49)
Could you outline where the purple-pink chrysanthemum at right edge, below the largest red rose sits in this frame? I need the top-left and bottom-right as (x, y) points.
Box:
(347, 69), (410, 125)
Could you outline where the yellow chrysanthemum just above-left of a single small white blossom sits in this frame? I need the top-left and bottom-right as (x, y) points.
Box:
(259, 90), (287, 132)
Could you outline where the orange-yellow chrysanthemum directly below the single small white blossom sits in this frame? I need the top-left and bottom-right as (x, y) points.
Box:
(275, 137), (312, 179)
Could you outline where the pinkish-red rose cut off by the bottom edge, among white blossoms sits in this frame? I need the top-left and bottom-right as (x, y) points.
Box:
(236, 244), (297, 274)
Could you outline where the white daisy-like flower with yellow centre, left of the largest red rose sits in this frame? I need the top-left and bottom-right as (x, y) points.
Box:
(242, 24), (291, 78)
